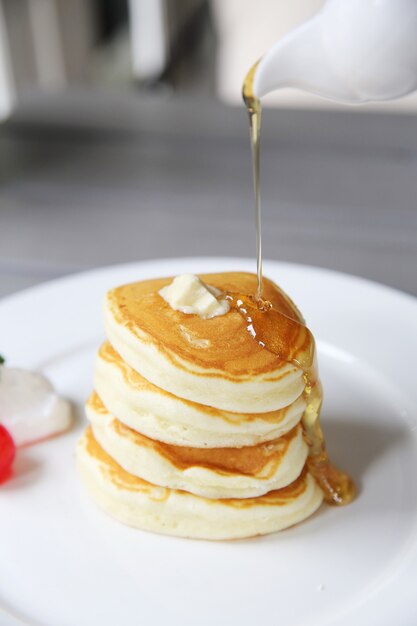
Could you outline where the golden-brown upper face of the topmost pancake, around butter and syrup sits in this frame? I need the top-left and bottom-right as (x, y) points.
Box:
(108, 272), (303, 380)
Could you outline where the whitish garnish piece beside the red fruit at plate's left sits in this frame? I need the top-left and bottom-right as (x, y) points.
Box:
(0, 366), (71, 447)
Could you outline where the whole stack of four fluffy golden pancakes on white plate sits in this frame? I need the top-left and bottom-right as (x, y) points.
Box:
(77, 272), (323, 539)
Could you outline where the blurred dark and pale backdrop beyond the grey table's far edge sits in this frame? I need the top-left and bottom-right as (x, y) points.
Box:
(0, 0), (417, 116)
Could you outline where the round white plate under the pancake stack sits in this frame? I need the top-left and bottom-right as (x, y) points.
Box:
(0, 259), (417, 626)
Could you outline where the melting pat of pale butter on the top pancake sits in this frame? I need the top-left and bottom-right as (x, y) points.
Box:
(159, 274), (230, 319)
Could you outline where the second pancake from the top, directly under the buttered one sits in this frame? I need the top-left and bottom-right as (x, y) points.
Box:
(95, 343), (305, 448)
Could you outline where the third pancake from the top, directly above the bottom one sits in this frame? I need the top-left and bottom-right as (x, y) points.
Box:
(86, 393), (308, 498)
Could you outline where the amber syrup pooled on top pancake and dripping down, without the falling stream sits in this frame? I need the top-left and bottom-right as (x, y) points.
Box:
(226, 293), (356, 505)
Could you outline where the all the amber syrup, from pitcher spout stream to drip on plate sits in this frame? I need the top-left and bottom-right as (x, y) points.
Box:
(240, 63), (356, 505)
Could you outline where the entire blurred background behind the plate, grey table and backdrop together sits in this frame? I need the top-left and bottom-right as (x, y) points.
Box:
(0, 0), (417, 295)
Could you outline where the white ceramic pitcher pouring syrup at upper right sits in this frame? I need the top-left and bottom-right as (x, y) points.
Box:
(253, 0), (417, 104)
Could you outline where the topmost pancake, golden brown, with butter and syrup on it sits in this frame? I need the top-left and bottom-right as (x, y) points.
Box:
(104, 272), (305, 413)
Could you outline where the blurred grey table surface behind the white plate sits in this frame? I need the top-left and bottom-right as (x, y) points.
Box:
(0, 91), (417, 296)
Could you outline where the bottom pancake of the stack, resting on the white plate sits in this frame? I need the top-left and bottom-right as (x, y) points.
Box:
(77, 428), (323, 539)
